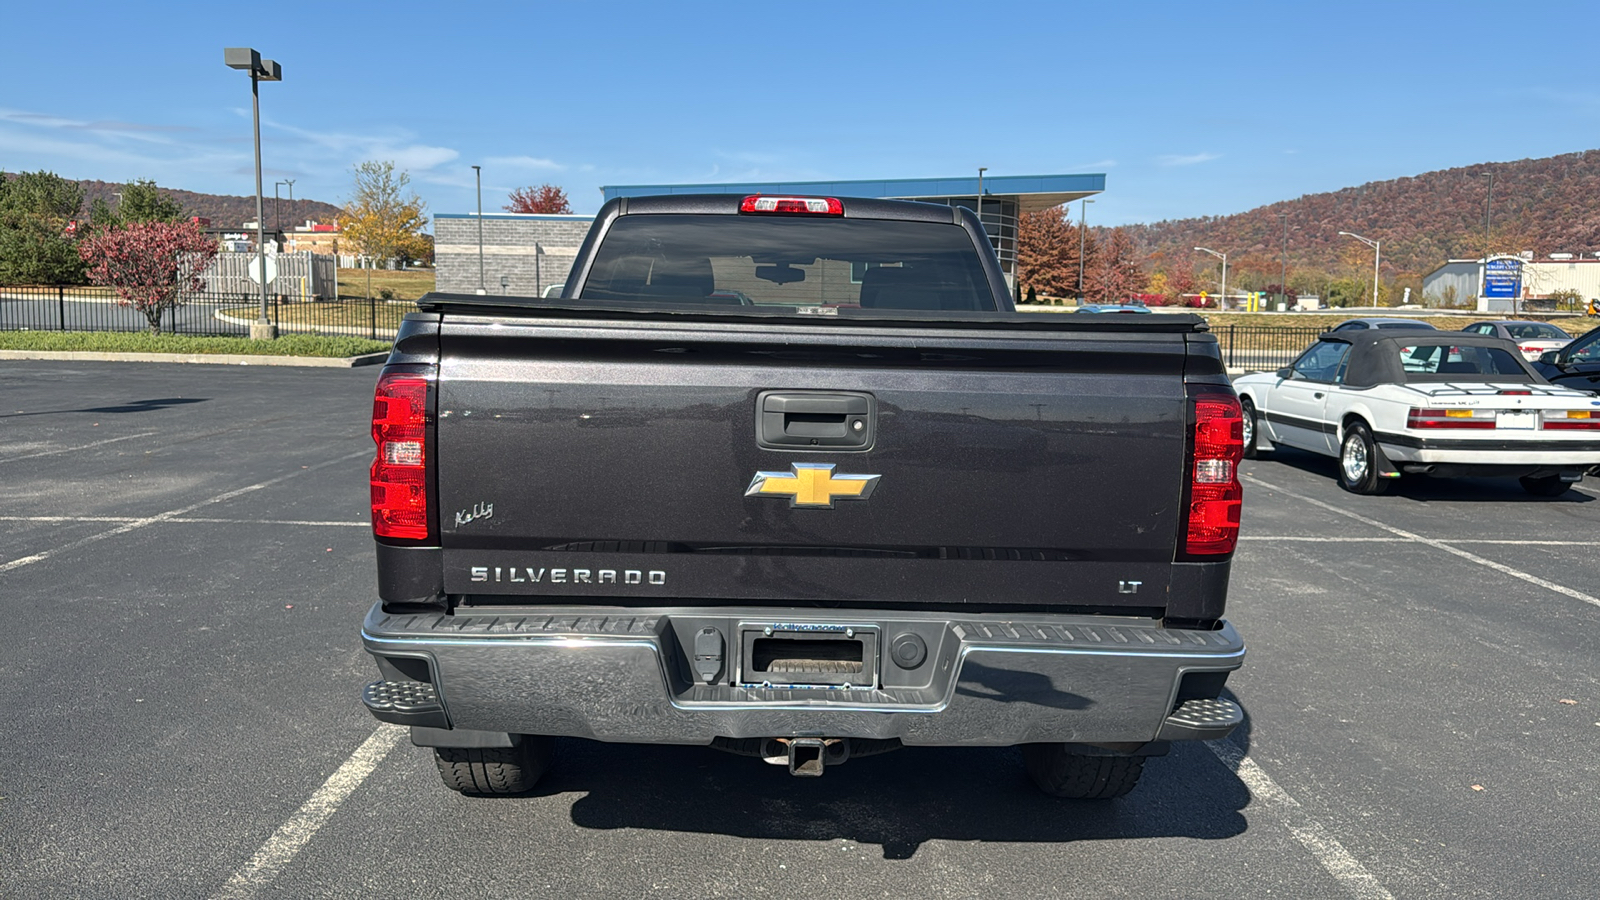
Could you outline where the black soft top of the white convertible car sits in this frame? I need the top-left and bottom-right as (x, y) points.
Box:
(1318, 330), (1544, 388)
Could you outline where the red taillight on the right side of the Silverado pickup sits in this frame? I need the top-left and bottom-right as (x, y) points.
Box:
(1184, 384), (1245, 556)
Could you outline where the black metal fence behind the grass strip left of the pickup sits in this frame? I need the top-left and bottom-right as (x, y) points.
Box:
(0, 287), (416, 340)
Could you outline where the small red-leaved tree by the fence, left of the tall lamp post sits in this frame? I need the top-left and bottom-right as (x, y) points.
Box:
(78, 223), (216, 335)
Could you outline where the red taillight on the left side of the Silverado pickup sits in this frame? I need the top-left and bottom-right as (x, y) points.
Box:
(371, 372), (429, 538)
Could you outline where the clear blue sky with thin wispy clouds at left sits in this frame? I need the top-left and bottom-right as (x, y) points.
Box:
(0, 2), (1600, 224)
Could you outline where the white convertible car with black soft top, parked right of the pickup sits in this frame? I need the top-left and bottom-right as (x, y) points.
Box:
(1234, 330), (1600, 496)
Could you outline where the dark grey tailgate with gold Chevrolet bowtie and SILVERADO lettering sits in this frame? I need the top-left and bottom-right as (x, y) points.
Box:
(437, 315), (1186, 610)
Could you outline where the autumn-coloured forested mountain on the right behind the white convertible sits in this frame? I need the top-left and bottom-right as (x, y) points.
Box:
(1128, 151), (1600, 285)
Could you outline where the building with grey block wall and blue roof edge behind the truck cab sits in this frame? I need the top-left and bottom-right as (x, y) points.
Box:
(434, 175), (1106, 296)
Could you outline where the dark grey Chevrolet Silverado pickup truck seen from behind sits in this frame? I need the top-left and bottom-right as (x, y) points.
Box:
(362, 195), (1245, 798)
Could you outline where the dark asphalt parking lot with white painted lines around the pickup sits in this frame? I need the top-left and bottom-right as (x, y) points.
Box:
(0, 362), (1600, 897)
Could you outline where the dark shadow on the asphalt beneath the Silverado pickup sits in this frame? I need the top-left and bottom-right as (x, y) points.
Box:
(536, 693), (1250, 860)
